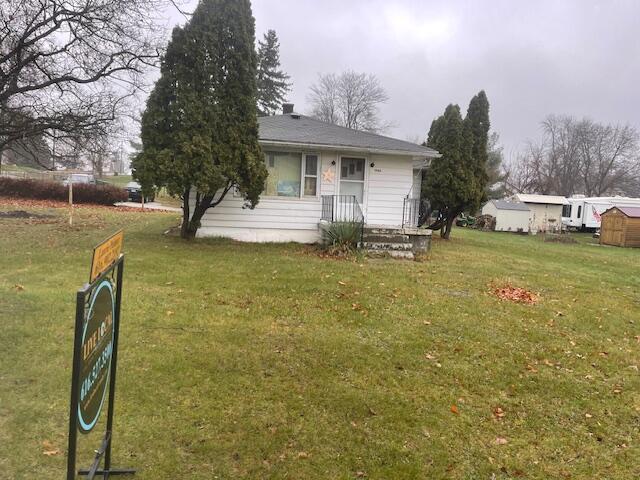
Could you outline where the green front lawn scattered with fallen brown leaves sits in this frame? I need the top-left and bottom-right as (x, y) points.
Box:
(0, 207), (640, 480)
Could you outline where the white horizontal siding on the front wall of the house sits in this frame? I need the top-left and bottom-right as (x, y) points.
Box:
(191, 149), (413, 243)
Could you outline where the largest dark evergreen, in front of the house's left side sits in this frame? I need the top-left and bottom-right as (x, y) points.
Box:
(132, 0), (267, 238)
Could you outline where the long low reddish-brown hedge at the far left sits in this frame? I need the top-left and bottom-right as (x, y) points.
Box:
(0, 178), (127, 205)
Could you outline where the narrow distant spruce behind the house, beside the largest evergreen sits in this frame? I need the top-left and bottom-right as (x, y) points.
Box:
(258, 30), (291, 115)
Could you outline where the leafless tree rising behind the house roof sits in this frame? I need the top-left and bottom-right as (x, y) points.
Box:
(308, 71), (390, 132)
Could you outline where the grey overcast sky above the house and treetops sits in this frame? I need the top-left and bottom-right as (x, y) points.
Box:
(164, 0), (640, 157)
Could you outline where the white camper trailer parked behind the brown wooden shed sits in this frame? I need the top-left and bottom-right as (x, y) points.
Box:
(562, 195), (640, 230)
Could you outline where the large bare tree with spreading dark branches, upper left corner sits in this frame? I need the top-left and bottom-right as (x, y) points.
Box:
(0, 0), (165, 168)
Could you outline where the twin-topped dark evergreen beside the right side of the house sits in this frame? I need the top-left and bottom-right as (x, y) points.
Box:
(422, 92), (490, 239)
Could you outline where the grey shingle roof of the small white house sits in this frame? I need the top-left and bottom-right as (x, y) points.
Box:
(258, 114), (439, 157)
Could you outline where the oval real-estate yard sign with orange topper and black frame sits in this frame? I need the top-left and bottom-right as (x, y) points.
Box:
(67, 231), (135, 480)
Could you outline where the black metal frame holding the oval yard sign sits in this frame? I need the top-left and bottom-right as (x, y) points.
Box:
(67, 254), (136, 480)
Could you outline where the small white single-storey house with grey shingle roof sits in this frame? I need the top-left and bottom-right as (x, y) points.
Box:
(198, 104), (439, 248)
